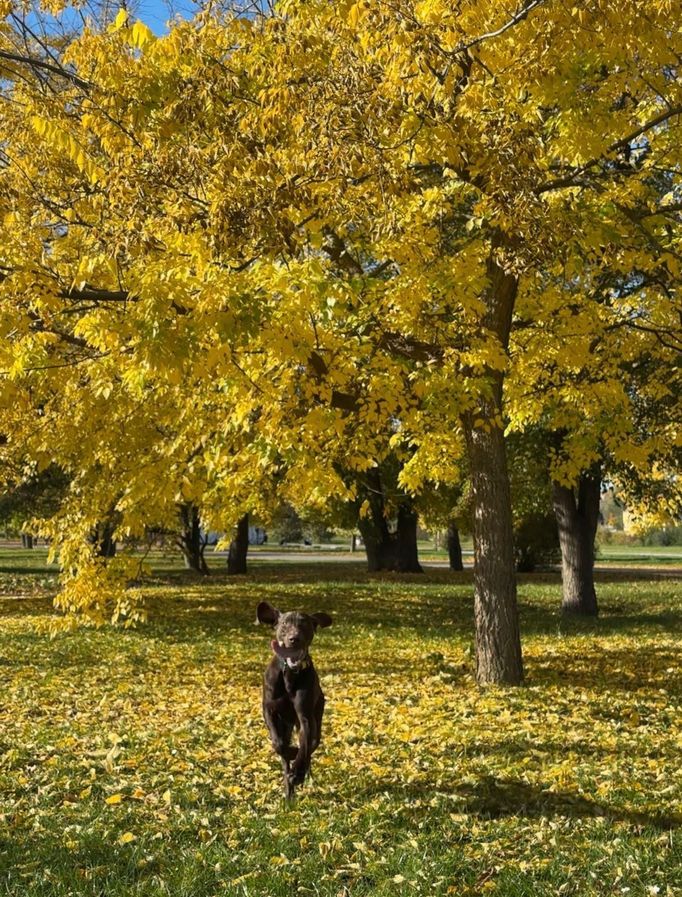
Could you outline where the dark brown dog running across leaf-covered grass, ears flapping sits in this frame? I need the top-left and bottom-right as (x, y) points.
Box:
(256, 601), (332, 799)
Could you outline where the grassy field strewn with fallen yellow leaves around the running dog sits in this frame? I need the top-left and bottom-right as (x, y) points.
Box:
(0, 552), (682, 897)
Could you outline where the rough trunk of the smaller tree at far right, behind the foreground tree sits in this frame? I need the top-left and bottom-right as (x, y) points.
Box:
(552, 467), (601, 617)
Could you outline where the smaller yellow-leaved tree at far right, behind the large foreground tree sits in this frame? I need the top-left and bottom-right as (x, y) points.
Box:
(509, 260), (682, 615)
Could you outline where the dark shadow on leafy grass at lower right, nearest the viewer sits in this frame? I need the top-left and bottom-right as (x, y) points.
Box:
(363, 776), (682, 831)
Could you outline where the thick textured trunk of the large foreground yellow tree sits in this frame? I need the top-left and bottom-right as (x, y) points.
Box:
(462, 234), (523, 685)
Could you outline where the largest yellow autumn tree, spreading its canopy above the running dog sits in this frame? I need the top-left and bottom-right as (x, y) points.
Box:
(0, 0), (682, 684)
